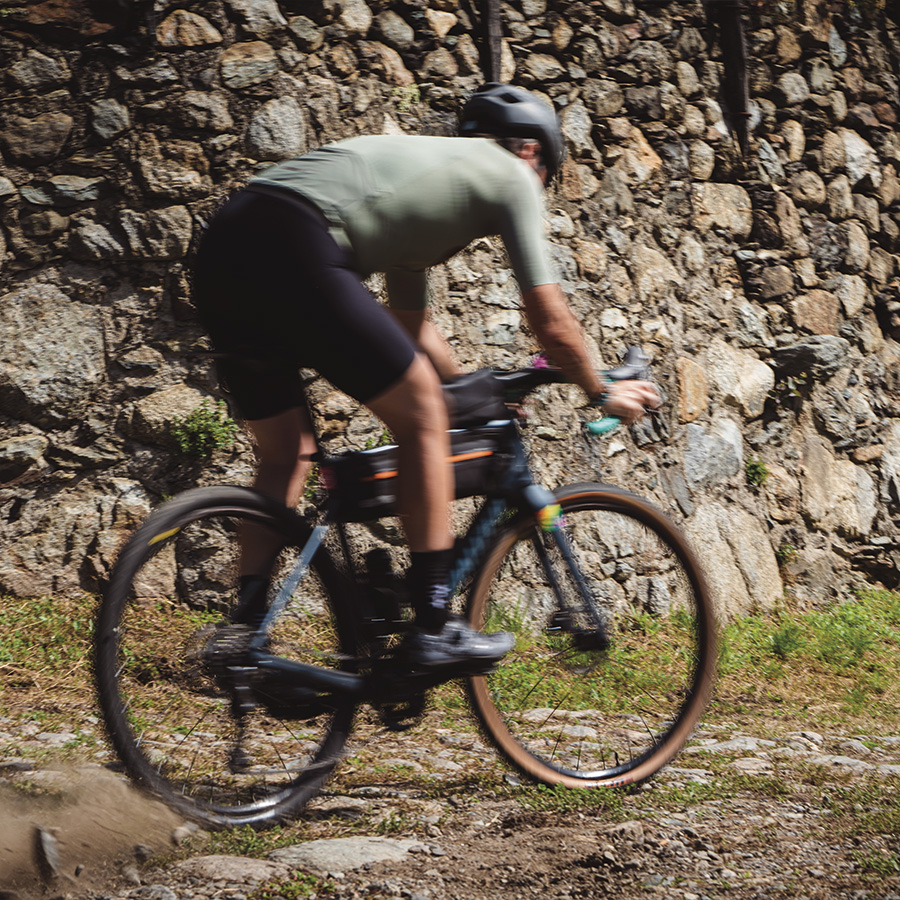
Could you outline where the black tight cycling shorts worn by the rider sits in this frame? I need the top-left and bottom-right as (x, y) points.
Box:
(194, 188), (416, 420)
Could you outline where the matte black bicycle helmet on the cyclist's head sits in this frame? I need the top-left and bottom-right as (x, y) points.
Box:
(459, 81), (565, 181)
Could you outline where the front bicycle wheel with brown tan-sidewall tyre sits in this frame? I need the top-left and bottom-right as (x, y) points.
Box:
(468, 484), (717, 787)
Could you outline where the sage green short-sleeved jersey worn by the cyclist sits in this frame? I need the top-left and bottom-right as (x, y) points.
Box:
(250, 135), (557, 309)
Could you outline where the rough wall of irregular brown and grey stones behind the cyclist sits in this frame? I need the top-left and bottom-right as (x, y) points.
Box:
(0, 0), (900, 614)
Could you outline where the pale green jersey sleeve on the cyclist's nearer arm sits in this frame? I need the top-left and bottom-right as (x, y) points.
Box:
(500, 162), (559, 291)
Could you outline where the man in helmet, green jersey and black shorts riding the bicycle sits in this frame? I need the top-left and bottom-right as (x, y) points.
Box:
(194, 83), (659, 671)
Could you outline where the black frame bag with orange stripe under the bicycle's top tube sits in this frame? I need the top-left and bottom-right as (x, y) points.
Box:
(319, 425), (505, 522)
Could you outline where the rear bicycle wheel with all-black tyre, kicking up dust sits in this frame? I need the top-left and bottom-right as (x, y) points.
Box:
(95, 487), (355, 829)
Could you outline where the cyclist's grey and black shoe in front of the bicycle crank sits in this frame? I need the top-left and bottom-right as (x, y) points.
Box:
(402, 616), (516, 675)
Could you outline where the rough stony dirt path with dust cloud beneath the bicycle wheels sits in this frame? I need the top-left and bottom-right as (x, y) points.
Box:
(0, 713), (900, 900)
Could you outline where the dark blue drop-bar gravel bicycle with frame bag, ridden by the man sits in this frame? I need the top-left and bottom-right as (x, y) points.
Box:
(95, 348), (717, 828)
